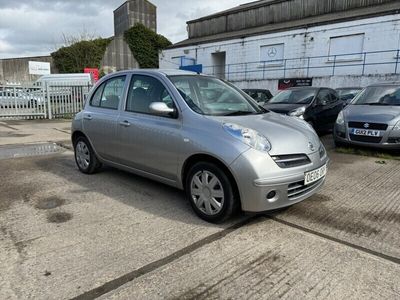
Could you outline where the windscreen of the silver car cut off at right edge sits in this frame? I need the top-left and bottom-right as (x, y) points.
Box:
(351, 85), (400, 106)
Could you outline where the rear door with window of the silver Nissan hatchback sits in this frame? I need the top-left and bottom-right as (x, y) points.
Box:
(83, 75), (126, 161)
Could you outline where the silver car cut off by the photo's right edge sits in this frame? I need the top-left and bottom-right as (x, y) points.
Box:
(334, 82), (400, 150)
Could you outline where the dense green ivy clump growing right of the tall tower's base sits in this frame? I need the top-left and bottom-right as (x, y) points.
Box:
(124, 23), (172, 68)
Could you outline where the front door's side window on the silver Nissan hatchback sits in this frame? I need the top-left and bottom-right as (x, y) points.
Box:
(126, 75), (175, 114)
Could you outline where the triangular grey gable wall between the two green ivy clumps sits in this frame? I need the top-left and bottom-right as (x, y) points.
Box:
(101, 36), (139, 74)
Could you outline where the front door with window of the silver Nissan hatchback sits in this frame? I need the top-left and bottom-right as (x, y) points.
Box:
(118, 75), (183, 180)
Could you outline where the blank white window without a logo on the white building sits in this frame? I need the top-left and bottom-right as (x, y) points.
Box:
(329, 34), (364, 61)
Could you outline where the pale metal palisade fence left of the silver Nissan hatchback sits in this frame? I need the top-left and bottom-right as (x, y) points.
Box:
(0, 82), (91, 119)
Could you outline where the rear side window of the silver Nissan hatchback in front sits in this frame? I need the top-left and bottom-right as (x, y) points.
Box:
(90, 76), (125, 109)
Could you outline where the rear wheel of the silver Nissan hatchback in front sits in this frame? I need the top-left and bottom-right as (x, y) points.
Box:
(74, 136), (101, 174)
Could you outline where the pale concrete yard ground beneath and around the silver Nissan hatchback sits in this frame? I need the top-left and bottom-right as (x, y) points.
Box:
(0, 121), (400, 299)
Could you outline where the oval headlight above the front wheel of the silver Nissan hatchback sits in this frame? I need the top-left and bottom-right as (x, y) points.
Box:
(223, 123), (271, 152)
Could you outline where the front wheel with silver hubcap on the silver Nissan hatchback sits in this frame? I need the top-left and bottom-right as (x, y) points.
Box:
(185, 162), (239, 223)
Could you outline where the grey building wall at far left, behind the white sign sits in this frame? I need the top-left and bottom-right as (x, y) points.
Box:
(0, 56), (58, 84)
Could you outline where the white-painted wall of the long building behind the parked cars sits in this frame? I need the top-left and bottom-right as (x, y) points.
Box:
(160, 14), (400, 94)
